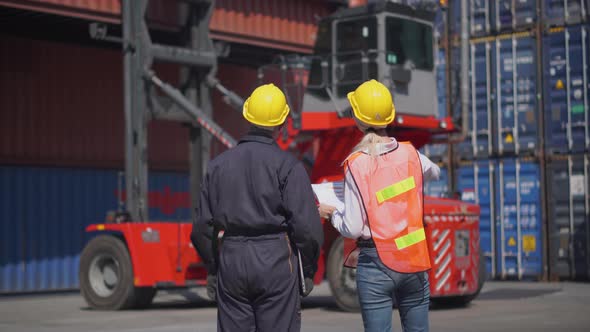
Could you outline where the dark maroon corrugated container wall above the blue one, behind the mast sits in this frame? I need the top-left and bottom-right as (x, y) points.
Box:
(0, 35), (256, 170)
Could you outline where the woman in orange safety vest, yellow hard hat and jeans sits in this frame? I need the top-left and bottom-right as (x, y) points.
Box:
(319, 80), (440, 332)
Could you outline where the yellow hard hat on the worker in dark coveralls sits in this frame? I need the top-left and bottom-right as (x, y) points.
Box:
(243, 83), (289, 127)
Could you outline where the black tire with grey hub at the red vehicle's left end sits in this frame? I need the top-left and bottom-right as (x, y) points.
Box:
(79, 235), (156, 310)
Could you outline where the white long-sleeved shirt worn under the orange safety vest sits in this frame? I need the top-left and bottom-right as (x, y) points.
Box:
(332, 137), (440, 239)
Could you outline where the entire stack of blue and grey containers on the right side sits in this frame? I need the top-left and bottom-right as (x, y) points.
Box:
(445, 0), (590, 279)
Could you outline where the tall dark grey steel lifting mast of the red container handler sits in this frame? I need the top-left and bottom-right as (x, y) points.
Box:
(118, 0), (242, 221)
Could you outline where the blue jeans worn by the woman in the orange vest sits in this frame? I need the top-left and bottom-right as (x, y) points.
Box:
(356, 248), (430, 332)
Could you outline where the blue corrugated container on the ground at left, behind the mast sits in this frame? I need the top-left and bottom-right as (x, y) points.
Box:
(0, 166), (190, 293)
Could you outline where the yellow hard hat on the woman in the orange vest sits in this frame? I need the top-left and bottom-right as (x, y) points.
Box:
(347, 80), (395, 127)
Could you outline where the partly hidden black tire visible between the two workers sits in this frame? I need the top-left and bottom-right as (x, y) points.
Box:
(326, 237), (361, 312)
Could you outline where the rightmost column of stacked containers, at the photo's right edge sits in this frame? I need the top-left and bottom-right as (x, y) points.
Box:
(543, 22), (590, 279)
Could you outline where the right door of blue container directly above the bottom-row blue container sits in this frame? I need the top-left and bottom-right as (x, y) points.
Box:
(493, 35), (539, 156)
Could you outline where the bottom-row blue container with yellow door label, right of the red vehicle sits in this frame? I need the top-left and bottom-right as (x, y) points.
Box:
(457, 158), (544, 280)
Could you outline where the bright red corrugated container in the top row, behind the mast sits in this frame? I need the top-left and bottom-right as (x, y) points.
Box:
(0, 0), (333, 53)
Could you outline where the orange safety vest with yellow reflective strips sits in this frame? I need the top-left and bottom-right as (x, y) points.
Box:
(344, 142), (430, 273)
